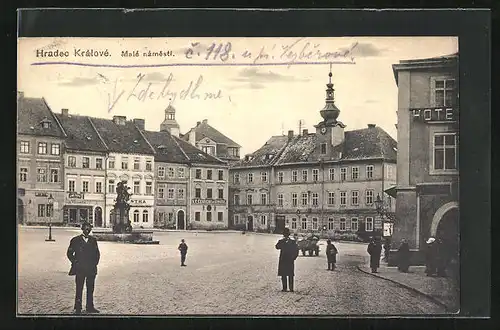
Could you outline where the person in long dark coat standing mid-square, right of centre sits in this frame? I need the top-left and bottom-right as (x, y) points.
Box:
(276, 228), (299, 292)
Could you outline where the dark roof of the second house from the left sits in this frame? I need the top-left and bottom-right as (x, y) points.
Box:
(54, 114), (107, 152)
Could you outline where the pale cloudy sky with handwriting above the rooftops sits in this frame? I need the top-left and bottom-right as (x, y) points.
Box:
(18, 37), (458, 155)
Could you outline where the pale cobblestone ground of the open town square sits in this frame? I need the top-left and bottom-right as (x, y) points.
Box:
(18, 228), (445, 315)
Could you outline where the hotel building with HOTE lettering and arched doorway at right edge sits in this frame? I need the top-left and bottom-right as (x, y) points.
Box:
(393, 53), (459, 263)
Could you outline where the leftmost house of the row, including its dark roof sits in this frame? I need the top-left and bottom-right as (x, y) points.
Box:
(17, 93), (65, 224)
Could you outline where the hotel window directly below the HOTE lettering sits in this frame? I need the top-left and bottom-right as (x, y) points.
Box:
(434, 133), (457, 171)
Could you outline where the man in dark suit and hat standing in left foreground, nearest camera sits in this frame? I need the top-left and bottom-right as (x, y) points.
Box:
(66, 222), (101, 314)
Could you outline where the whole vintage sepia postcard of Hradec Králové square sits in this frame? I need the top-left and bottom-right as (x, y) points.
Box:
(17, 37), (460, 317)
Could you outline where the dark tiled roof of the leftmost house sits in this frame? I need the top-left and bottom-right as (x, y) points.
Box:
(17, 97), (64, 138)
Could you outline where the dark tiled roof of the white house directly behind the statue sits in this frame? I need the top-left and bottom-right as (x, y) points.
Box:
(90, 118), (154, 155)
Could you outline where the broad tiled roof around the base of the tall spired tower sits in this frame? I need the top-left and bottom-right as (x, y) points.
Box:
(274, 127), (397, 165)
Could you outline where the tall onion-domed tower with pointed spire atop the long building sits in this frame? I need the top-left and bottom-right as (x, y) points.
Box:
(315, 64), (346, 147)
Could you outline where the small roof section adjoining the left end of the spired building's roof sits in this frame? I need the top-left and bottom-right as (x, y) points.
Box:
(231, 135), (288, 168)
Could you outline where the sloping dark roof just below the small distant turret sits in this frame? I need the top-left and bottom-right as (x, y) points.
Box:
(142, 131), (226, 165)
